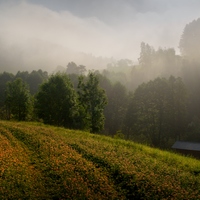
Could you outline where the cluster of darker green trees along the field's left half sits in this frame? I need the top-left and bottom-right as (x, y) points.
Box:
(0, 70), (107, 133)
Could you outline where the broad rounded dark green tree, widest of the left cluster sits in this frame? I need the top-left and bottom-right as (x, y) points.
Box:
(35, 74), (78, 128)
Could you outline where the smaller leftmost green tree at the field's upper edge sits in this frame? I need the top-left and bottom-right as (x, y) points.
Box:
(5, 78), (31, 121)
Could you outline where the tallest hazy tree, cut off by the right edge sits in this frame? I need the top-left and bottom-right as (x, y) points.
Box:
(179, 18), (200, 120)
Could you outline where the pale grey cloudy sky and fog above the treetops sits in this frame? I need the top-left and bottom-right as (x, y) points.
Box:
(0, 0), (200, 70)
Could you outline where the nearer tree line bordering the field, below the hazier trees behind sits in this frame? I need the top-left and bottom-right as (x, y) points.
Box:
(0, 66), (187, 147)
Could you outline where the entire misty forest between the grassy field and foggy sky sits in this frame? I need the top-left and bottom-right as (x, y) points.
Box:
(0, 19), (200, 148)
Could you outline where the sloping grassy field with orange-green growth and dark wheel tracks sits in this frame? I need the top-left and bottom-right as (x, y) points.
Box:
(0, 121), (200, 200)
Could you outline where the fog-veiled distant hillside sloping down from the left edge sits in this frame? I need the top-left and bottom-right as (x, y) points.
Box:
(0, 38), (114, 73)
